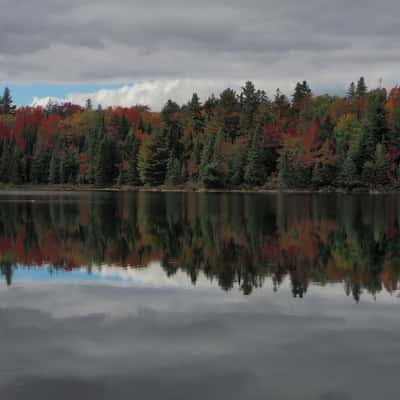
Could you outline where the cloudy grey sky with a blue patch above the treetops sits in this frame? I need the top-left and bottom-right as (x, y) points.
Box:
(0, 0), (400, 109)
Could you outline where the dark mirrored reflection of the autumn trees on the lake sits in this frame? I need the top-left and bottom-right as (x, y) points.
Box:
(0, 192), (400, 301)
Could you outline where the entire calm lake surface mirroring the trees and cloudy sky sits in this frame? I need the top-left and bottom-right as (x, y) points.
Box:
(0, 192), (400, 400)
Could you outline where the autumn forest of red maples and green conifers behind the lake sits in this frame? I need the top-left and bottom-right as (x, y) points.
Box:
(0, 77), (400, 191)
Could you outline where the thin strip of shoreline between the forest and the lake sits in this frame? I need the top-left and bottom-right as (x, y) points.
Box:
(0, 185), (400, 195)
